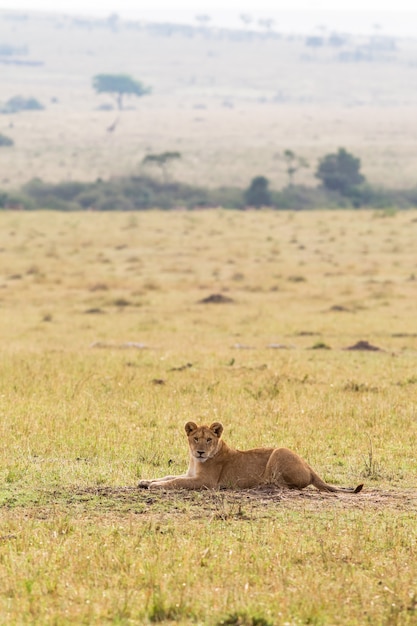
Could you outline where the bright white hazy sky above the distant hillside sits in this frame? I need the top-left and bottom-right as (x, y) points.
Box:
(0, 0), (417, 36)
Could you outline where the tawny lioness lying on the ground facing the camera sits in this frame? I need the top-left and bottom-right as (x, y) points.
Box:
(138, 422), (363, 493)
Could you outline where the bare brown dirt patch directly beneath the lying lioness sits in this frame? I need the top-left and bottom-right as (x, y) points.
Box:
(31, 486), (417, 519)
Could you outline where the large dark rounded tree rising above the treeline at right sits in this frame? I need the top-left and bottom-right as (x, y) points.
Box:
(316, 148), (365, 196)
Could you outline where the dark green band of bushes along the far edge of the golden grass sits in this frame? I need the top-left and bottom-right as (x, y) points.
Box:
(0, 176), (417, 211)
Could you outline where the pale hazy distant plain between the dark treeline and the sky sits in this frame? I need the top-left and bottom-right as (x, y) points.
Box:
(0, 12), (417, 189)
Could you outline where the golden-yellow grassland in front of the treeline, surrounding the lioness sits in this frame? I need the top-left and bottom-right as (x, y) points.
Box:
(0, 210), (417, 625)
